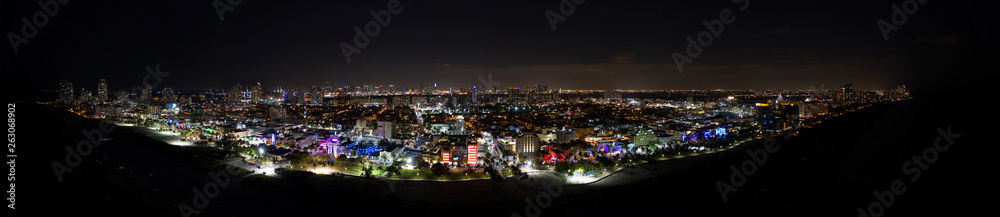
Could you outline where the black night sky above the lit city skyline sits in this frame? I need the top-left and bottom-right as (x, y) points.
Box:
(0, 0), (995, 90)
